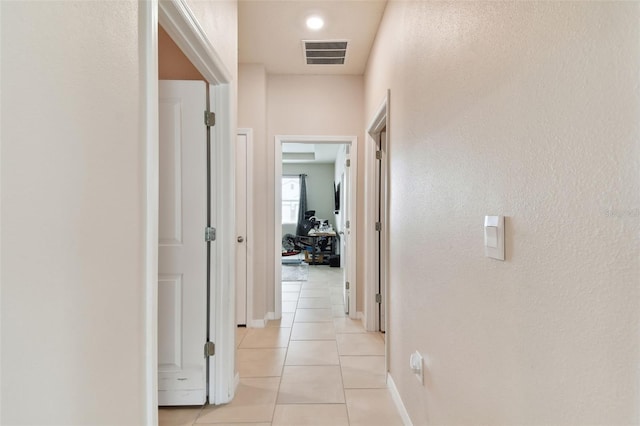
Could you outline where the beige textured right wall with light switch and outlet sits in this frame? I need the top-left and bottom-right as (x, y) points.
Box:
(365, 1), (640, 425)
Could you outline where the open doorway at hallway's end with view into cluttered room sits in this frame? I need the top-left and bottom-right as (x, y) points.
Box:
(274, 136), (357, 319)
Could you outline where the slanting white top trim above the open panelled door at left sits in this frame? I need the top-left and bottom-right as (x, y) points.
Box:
(158, 0), (231, 84)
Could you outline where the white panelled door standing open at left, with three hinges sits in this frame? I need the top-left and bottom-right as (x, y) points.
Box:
(158, 81), (207, 405)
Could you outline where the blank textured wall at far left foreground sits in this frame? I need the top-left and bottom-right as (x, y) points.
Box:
(0, 1), (145, 425)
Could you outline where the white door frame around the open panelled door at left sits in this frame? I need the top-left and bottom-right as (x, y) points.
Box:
(138, 0), (235, 425)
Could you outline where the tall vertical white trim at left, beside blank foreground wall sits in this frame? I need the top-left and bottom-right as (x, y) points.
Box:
(138, 0), (160, 426)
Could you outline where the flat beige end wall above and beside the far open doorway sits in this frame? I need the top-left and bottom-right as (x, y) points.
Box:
(266, 75), (364, 311)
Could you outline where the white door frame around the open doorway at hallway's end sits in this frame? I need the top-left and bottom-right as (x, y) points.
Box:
(270, 135), (358, 319)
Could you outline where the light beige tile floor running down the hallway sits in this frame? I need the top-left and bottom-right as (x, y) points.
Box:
(159, 266), (402, 426)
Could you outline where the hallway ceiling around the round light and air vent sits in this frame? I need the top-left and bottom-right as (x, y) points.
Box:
(238, 0), (386, 75)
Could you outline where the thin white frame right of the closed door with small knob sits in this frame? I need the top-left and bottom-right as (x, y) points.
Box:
(236, 128), (253, 327)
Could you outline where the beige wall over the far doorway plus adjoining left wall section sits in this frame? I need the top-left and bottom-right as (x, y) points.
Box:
(238, 71), (364, 320)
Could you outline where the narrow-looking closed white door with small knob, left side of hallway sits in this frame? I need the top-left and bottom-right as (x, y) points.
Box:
(236, 133), (248, 325)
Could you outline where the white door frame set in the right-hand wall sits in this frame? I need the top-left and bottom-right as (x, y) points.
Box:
(364, 91), (390, 332)
